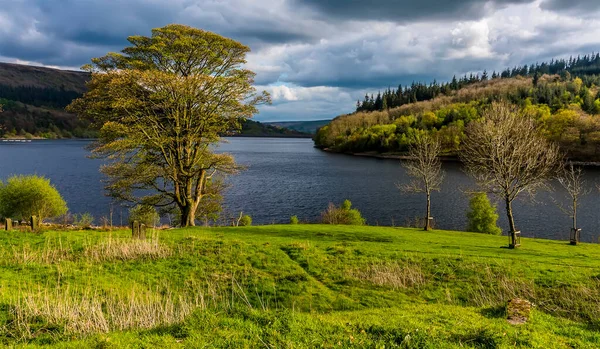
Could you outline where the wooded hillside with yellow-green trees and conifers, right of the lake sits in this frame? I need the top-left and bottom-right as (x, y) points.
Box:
(315, 54), (600, 161)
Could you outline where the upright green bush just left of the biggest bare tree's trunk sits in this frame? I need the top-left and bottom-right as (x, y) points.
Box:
(467, 193), (502, 235)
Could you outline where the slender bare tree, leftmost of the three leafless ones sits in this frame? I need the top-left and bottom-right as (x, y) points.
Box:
(397, 135), (444, 230)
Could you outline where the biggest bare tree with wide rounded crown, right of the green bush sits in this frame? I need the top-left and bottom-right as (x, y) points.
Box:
(460, 102), (561, 247)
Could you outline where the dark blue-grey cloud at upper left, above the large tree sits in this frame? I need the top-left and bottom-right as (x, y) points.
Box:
(0, 0), (314, 66)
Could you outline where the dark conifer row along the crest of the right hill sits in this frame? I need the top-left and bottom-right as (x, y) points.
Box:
(356, 53), (600, 112)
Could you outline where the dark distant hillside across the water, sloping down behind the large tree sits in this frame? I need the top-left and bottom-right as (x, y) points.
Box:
(0, 62), (304, 138)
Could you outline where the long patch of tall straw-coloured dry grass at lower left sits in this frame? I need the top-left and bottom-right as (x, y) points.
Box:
(5, 288), (206, 339)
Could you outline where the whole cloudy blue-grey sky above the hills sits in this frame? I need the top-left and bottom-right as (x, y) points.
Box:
(0, 0), (600, 121)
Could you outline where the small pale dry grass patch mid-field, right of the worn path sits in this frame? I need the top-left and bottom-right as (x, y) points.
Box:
(351, 263), (426, 289)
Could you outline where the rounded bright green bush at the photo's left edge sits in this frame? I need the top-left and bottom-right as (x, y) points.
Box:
(0, 175), (67, 222)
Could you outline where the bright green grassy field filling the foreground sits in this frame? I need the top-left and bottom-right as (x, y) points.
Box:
(0, 225), (600, 348)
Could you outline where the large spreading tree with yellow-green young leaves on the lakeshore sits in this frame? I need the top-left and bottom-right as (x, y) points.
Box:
(69, 24), (269, 226)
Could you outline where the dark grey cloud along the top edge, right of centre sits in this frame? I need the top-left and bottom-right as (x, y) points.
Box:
(294, 0), (533, 22)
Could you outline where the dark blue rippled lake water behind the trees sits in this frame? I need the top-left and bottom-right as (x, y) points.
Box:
(0, 138), (600, 242)
